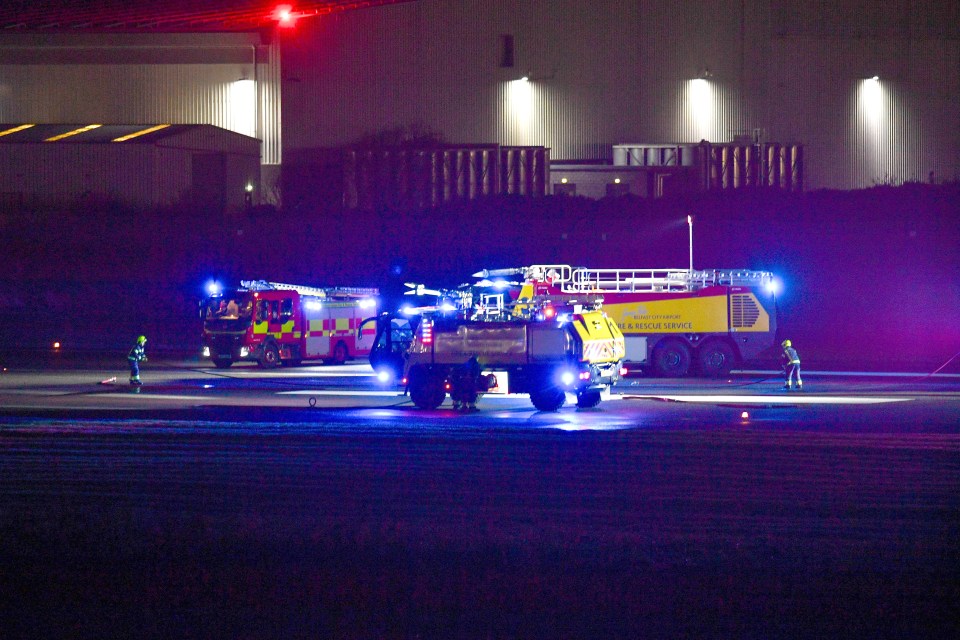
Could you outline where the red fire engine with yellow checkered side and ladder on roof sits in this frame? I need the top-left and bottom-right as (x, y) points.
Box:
(201, 280), (379, 369)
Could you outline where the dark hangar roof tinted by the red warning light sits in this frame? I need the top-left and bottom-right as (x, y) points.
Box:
(0, 0), (410, 34)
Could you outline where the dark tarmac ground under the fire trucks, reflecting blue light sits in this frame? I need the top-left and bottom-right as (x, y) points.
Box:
(0, 360), (960, 638)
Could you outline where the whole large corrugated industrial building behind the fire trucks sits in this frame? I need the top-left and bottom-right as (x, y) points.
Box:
(0, 0), (960, 206)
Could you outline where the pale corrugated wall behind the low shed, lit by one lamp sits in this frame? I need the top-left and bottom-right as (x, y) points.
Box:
(0, 34), (282, 164)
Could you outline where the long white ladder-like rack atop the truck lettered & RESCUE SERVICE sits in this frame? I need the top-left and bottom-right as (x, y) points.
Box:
(502, 265), (773, 294)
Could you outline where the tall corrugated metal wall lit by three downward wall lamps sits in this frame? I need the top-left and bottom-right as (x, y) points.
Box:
(283, 0), (960, 188)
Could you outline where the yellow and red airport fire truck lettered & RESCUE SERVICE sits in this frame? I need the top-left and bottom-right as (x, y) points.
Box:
(474, 265), (777, 377)
